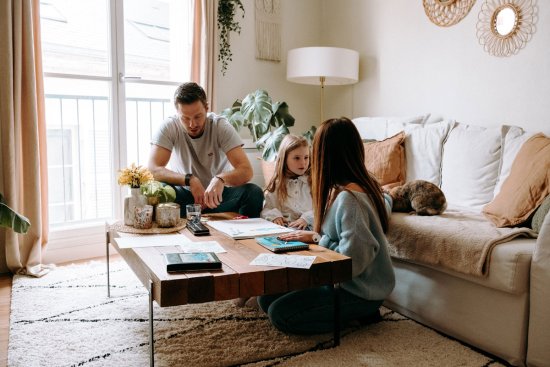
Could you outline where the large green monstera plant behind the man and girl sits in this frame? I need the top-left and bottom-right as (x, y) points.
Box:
(221, 89), (316, 183)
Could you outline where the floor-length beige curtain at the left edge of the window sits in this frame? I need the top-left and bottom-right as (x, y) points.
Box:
(0, 0), (48, 276)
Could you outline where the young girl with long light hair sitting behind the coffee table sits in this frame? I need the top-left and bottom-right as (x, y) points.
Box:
(260, 134), (313, 229)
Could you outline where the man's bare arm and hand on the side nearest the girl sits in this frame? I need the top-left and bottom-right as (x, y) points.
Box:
(204, 146), (253, 208)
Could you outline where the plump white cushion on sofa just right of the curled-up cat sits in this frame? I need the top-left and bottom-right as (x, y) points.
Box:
(441, 124), (502, 212)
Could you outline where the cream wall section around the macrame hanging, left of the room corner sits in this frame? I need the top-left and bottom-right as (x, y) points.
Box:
(215, 0), (322, 133)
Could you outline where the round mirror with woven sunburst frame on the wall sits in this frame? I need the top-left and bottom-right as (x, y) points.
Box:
(477, 0), (537, 56)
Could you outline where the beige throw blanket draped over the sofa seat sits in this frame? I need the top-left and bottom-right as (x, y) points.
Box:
(387, 210), (537, 276)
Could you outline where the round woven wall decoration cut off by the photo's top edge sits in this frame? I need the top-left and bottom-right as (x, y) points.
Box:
(422, 0), (476, 27)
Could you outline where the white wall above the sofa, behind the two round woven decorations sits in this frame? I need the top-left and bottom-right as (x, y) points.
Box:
(322, 0), (550, 131)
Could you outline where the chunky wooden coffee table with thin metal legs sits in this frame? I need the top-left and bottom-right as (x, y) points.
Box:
(105, 213), (351, 366)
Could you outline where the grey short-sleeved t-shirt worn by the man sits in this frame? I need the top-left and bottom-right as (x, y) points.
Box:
(151, 113), (243, 188)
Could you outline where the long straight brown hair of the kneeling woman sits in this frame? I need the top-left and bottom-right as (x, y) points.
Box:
(311, 117), (388, 232)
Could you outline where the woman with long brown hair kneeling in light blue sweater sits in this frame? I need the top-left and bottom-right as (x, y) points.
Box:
(258, 117), (395, 334)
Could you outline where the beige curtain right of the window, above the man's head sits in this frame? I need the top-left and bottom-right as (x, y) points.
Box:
(191, 0), (218, 111)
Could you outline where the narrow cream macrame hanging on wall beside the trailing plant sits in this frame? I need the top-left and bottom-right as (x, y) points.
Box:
(255, 0), (281, 61)
